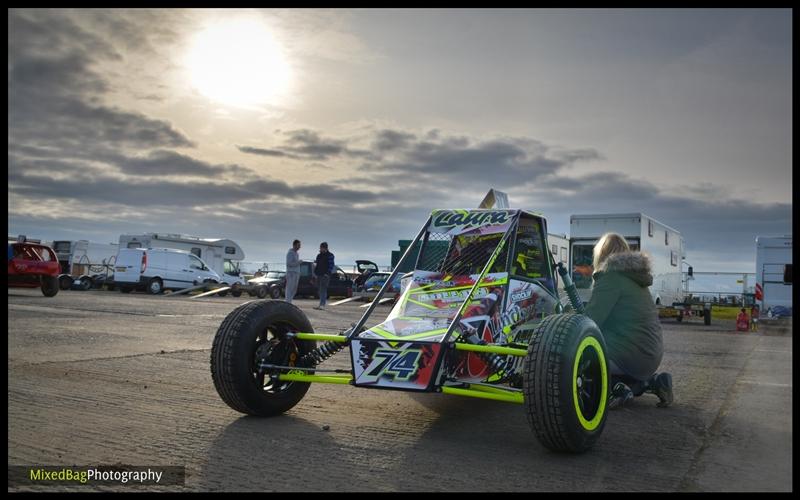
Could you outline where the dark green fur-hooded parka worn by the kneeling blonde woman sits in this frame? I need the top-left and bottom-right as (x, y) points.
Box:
(586, 252), (664, 380)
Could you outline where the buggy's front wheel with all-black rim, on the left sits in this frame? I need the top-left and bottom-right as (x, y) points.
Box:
(211, 300), (316, 417)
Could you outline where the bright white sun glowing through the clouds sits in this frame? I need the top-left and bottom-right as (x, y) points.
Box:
(185, 19), (291, 107)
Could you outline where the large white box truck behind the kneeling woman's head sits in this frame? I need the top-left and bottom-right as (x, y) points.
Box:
(569, 213), (685, 307)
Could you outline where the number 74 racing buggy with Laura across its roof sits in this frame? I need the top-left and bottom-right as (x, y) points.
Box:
(211, 209), (609, 452)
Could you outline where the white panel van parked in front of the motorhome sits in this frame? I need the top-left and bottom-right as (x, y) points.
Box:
(114, 248), (221, 294)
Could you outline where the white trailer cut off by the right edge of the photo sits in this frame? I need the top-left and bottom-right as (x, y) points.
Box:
(756, 235), (792, 317)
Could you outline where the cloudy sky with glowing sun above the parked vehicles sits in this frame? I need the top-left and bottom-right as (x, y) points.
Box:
(8, 9), (792, 278)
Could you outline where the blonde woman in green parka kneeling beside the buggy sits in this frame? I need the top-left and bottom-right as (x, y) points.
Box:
(586, 233), (672, 408)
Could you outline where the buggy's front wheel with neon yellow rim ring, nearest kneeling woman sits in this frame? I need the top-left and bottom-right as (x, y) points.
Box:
(523, 314), (610, 453)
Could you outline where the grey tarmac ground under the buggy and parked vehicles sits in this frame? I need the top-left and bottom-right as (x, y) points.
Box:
(8, 288), (792, 491)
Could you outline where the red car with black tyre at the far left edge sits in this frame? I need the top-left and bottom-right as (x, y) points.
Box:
(8, 243), (61, 297)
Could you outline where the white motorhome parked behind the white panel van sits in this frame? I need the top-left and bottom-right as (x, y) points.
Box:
(119, 233), (246, 285)
